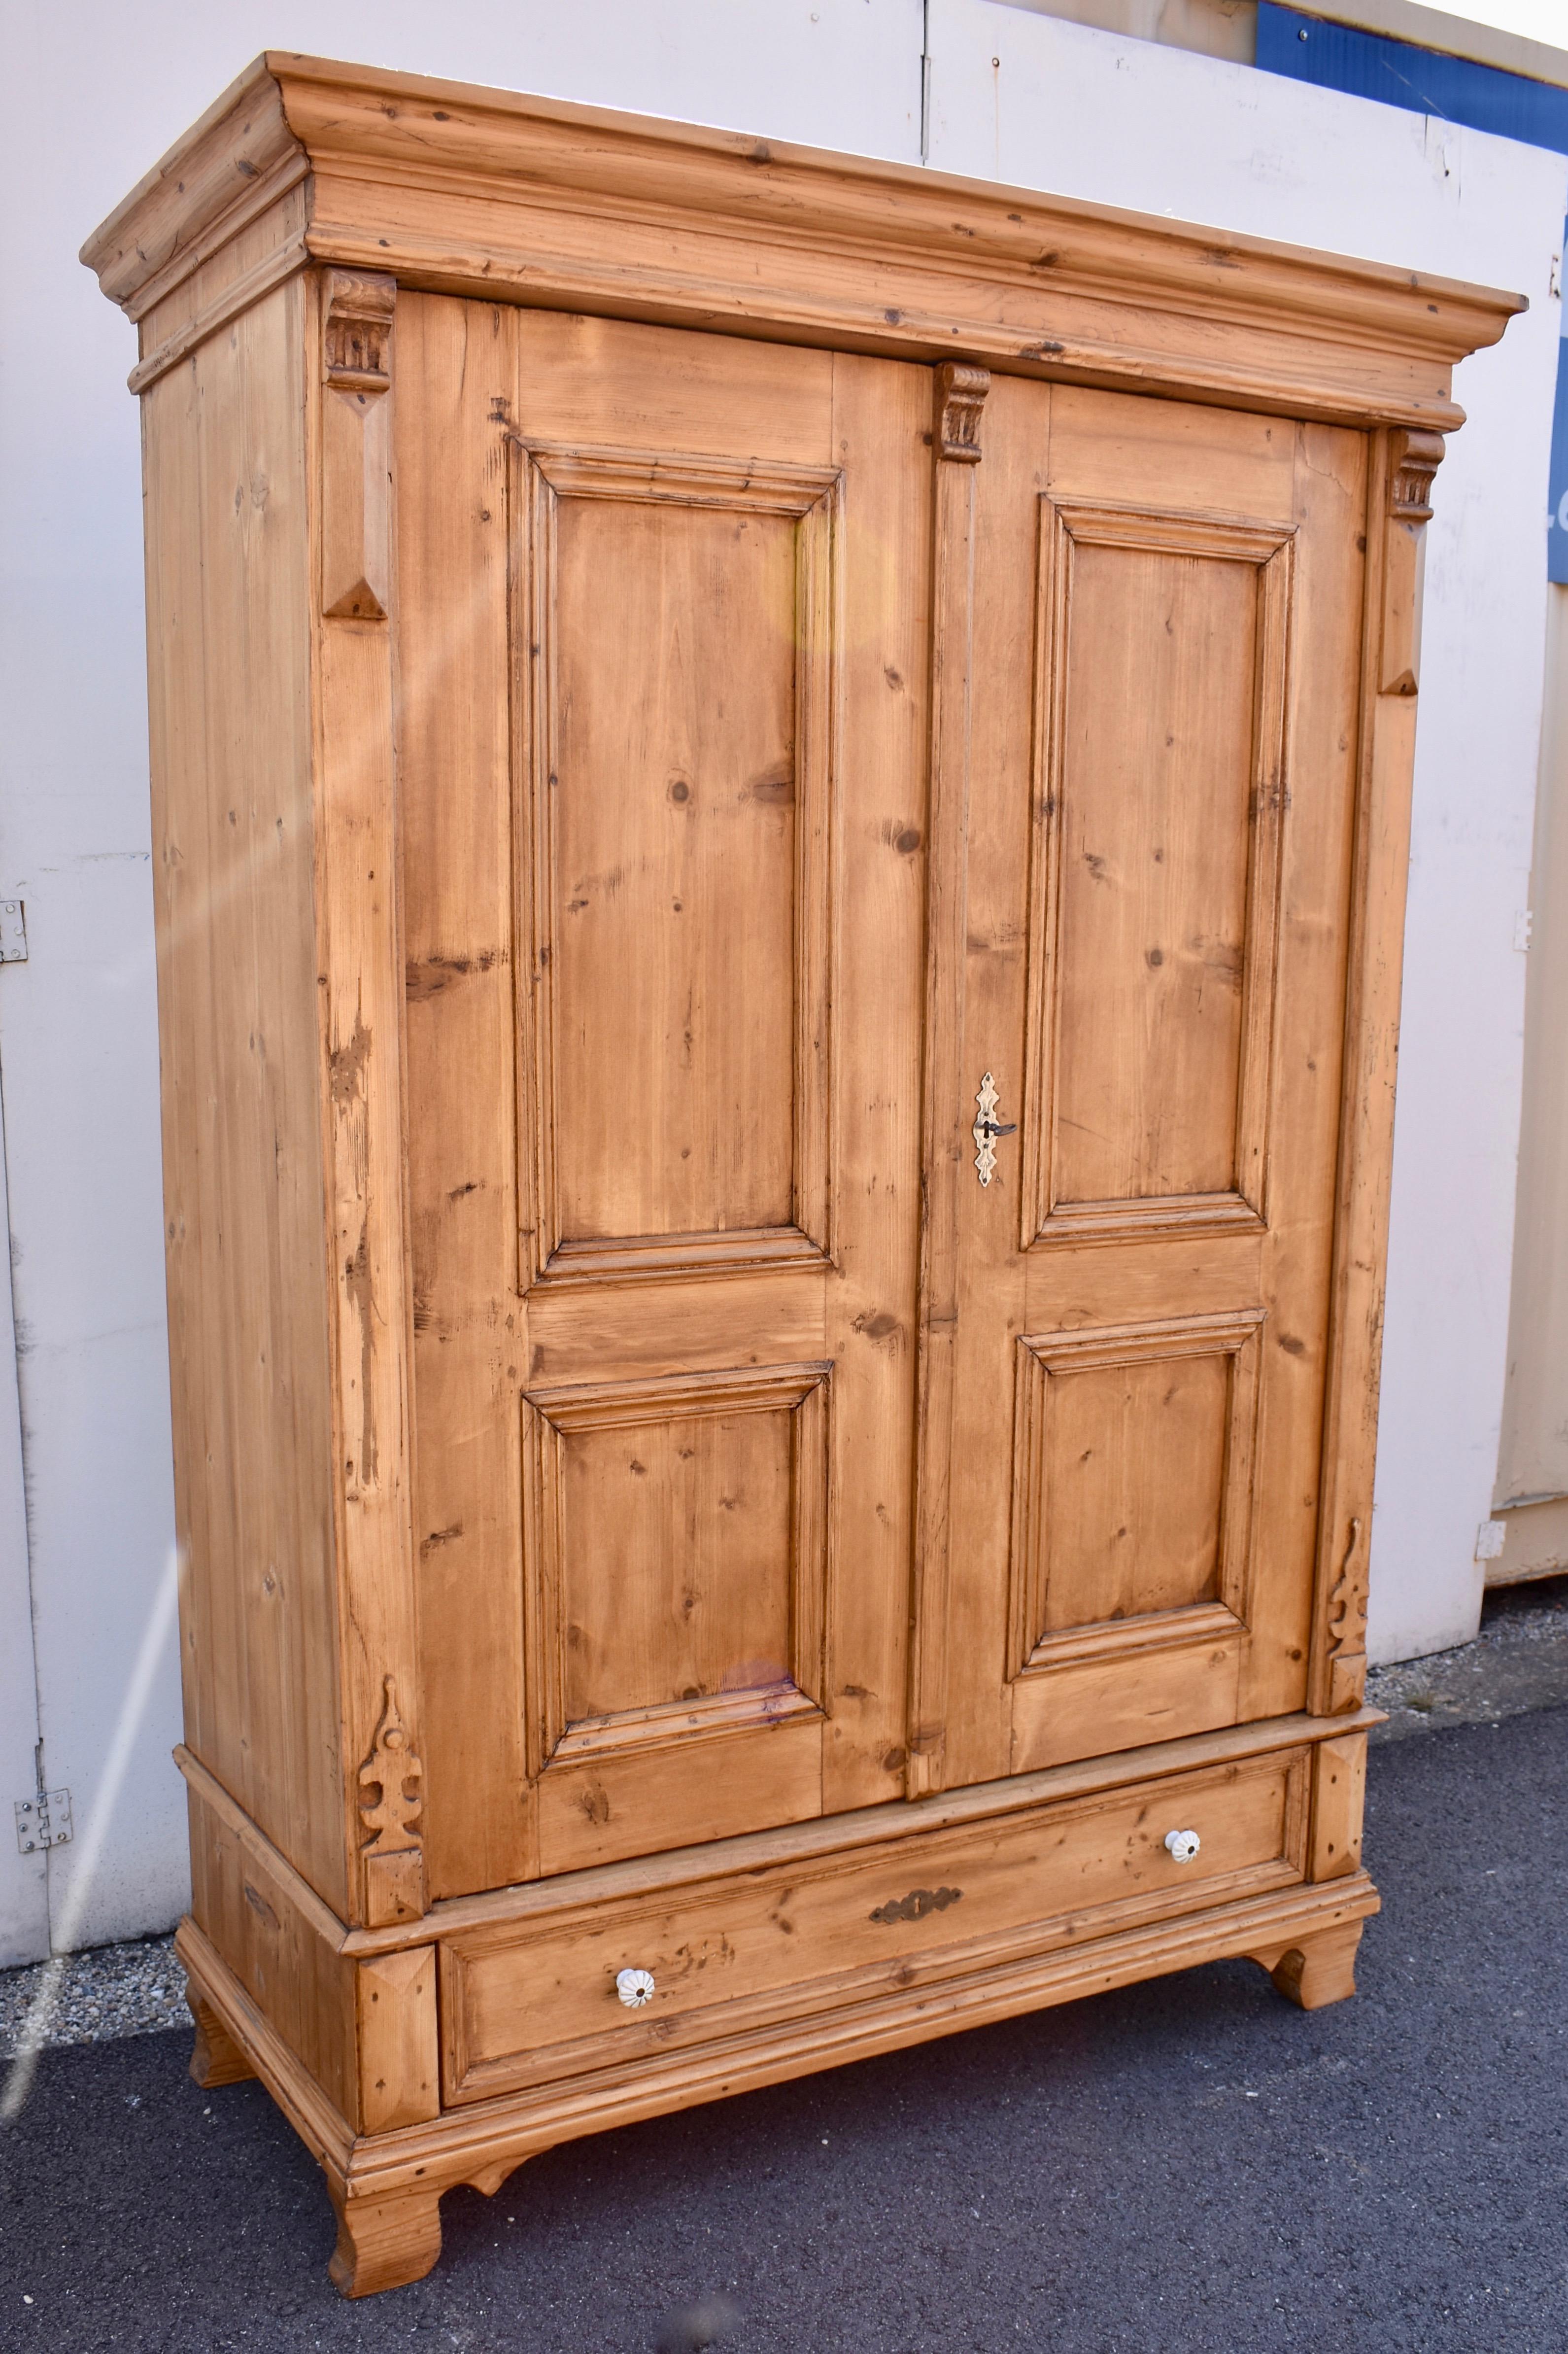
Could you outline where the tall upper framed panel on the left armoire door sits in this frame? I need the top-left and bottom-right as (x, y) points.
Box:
(513, 440), (838, 1283)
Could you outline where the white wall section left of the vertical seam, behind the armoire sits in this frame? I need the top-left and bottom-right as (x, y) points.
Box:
(0, 0), (920, 1963)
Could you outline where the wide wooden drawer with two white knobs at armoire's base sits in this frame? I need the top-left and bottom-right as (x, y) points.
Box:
(440, 1749), (1309, 2102)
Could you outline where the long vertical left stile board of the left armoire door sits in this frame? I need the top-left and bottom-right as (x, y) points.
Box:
(396, 294), (537, 1897)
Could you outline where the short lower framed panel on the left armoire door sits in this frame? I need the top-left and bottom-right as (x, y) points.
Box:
(525, 1365), (831, 1772)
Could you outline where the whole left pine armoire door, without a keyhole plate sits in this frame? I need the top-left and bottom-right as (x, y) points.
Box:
(396, 294), (930, 1895)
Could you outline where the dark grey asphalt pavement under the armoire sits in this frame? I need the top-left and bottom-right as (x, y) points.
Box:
(0, 1709), (1568, 2354)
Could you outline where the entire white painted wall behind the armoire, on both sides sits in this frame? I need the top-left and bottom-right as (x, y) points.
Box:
(0, 0), (1568, 1959)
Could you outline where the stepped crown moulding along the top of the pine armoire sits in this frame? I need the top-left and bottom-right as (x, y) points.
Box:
(82, 52), (1521, 428)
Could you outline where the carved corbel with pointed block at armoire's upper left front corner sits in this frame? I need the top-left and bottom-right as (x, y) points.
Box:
(320, 271), (398, 622)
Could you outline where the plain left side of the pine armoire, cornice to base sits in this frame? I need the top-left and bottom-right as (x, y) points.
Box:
(143, 278), (353, 2114)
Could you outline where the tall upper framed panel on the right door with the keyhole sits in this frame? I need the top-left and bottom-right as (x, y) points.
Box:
(1024, 499), (1293, 1243)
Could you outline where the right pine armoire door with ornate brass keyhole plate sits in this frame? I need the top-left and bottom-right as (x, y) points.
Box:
(911, 377), (1365, 1789)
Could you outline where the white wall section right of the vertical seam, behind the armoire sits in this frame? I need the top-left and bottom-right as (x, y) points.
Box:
(930, 0), (1568, 1660)
